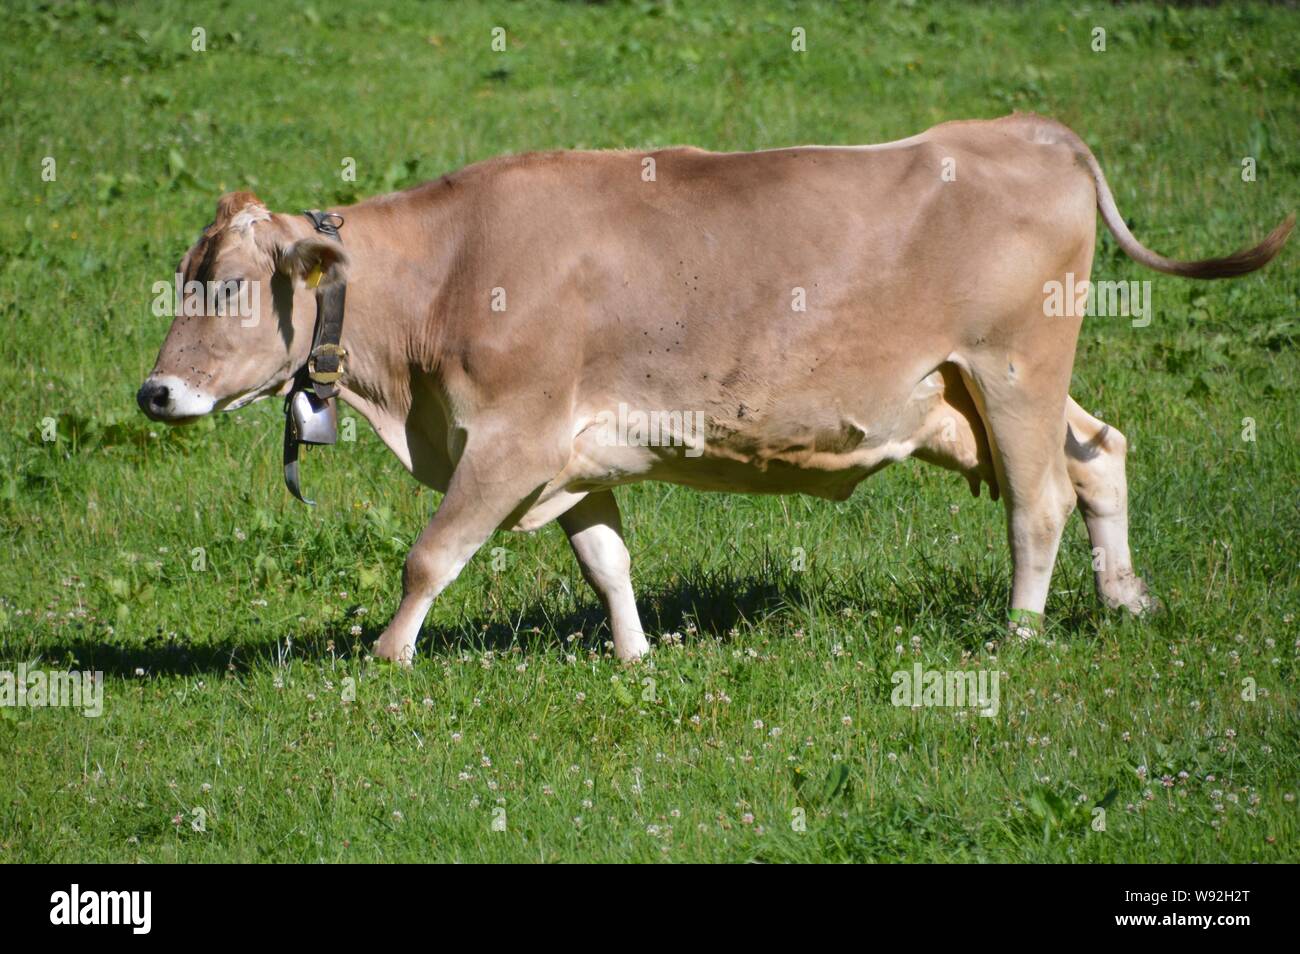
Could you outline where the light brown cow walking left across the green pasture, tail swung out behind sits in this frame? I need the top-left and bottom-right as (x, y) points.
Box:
(138, 113), (1295, 664)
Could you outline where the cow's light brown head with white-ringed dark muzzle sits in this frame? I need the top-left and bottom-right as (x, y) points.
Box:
(135, 192), (347, 424)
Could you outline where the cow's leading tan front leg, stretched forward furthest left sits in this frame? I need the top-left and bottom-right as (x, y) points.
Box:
(374, 450), (547, 665)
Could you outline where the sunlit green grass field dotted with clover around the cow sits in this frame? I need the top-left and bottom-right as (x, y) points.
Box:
(0, 0), (1300, 863)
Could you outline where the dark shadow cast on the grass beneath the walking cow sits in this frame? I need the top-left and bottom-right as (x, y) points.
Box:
(30, 556), (1099, 677)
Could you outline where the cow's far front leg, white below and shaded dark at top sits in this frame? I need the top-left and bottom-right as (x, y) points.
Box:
(559, 490), (650, 659)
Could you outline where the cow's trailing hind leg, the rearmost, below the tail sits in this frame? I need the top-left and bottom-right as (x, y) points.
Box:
(1065, 399), (1154, 613)
